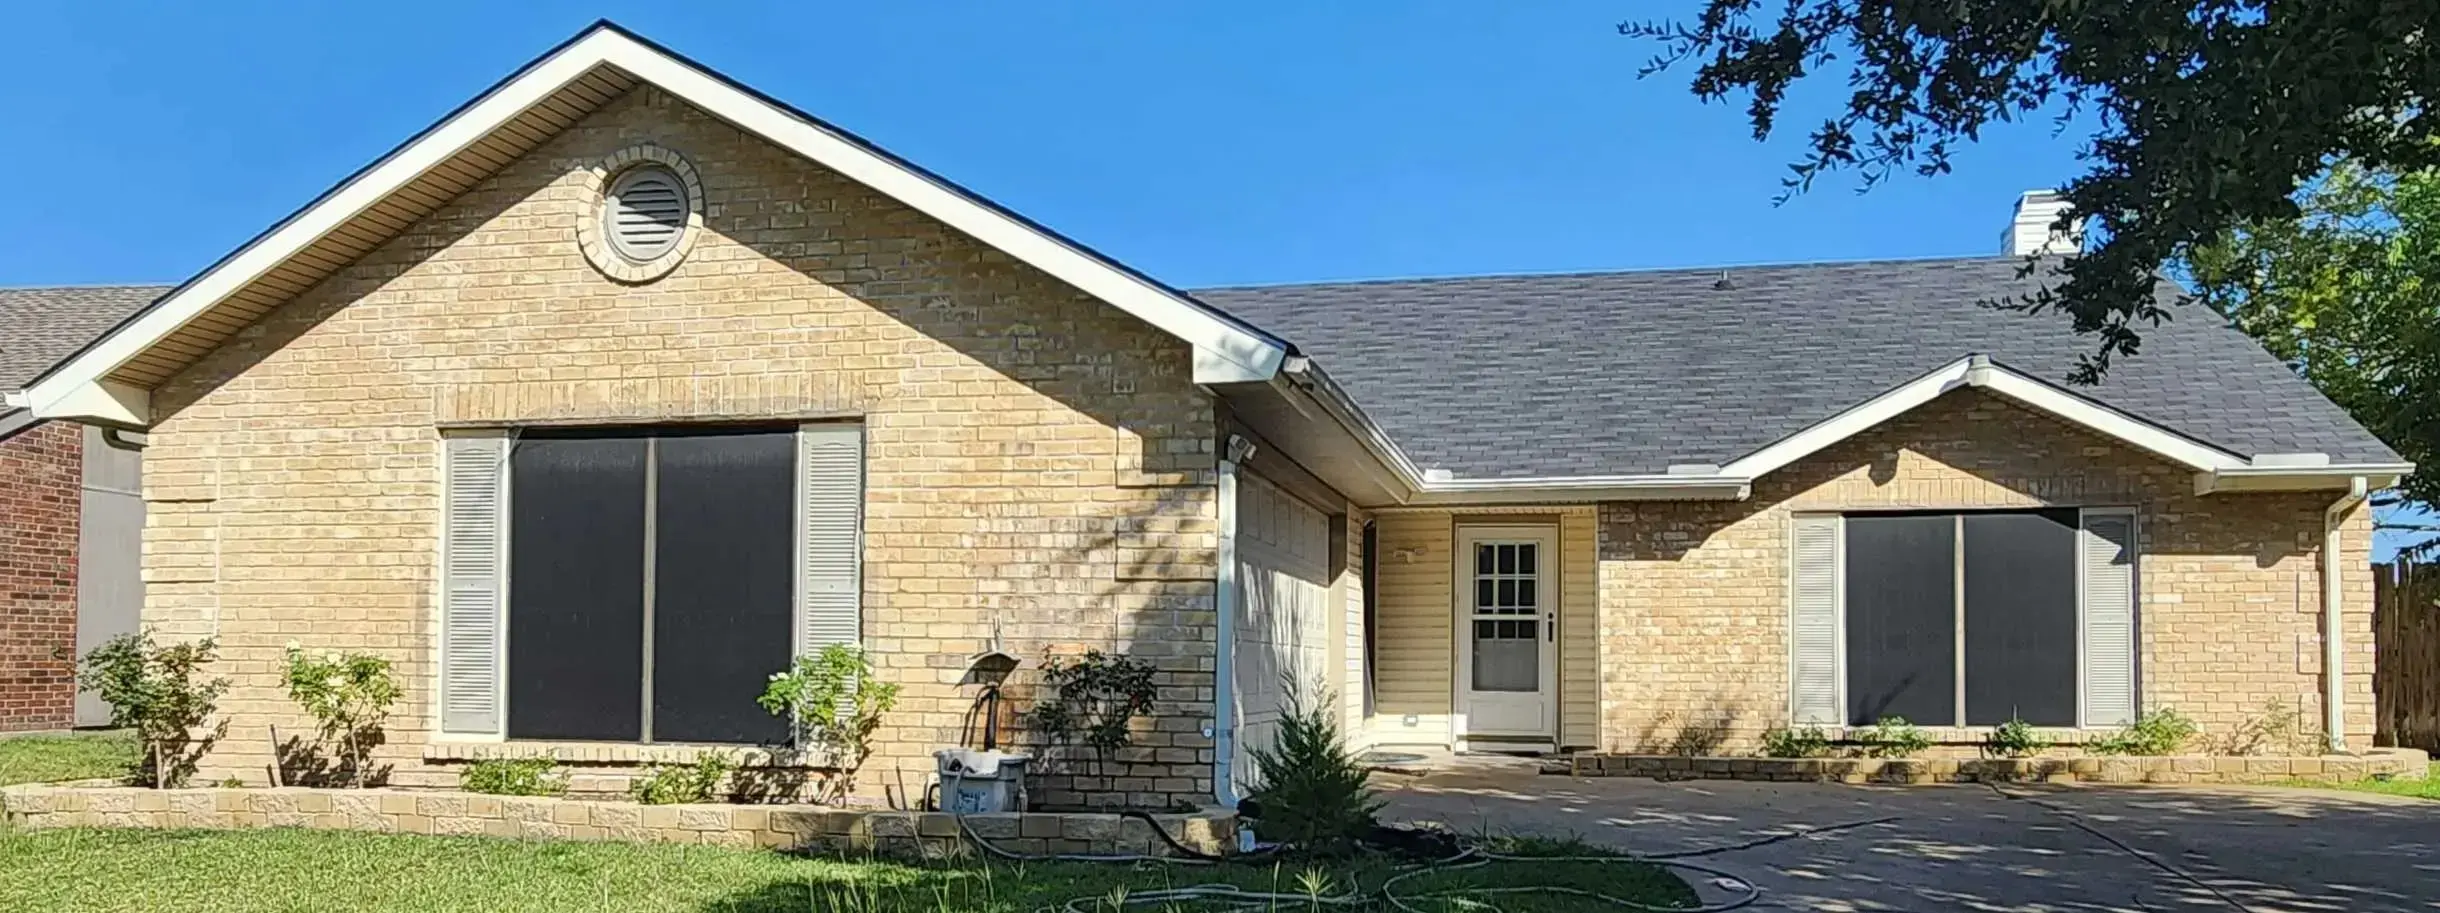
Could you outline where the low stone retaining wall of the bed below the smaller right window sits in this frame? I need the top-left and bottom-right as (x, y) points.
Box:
(1564, 749), (2428, 784)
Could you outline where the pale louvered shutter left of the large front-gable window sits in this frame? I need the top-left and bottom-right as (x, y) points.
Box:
(442, 435), (508, 735)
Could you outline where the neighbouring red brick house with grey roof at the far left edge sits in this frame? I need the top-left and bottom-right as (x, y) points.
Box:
(0, 286), (166, 732)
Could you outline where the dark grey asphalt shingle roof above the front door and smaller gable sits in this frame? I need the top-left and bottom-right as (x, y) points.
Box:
(1193, 256), (2399, 478)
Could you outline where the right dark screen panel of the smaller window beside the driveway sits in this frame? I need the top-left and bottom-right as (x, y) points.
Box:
(1964, 510), (2076, 725)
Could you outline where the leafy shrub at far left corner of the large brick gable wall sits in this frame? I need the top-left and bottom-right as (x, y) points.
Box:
(76, 632), (229, 789)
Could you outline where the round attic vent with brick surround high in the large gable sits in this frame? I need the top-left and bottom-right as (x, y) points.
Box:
(576, 144), (703, 283)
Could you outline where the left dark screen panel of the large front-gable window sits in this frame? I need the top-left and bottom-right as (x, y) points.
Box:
(508, 432), (644, 740)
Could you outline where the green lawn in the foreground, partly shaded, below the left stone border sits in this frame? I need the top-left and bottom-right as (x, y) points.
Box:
(0, 830), (1693, 913)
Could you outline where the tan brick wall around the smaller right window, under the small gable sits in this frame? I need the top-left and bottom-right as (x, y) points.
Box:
(1601, 391), (2372, 752)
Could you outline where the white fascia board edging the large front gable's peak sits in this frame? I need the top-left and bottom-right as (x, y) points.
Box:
(29, 27), (1286, 403)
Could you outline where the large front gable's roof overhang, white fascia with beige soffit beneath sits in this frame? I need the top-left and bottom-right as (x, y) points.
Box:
(24, 22), (1288, 425)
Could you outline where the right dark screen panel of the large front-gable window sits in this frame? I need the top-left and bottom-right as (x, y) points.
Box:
(651, 430), (795, 745)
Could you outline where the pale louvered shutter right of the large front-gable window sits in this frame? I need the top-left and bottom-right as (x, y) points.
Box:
(795, 422), (864, 654)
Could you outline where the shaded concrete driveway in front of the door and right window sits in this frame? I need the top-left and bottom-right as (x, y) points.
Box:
(1381, 764), (2440, 913)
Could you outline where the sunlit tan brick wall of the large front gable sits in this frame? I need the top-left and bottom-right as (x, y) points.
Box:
(144, 90), (1215, 803)
